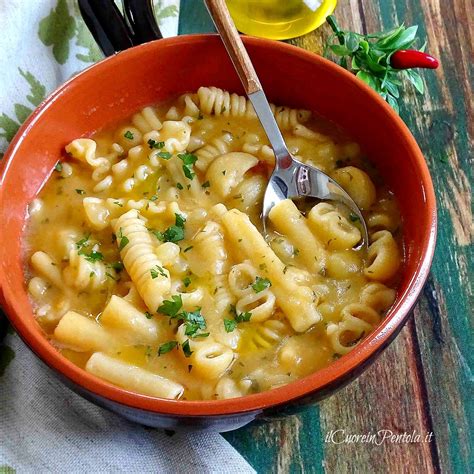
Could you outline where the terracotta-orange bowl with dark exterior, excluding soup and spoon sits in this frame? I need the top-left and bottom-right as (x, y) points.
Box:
(0, 35), (436, 431)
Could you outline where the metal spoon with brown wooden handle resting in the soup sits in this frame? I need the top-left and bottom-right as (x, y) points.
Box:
(205, 0), (369, 246)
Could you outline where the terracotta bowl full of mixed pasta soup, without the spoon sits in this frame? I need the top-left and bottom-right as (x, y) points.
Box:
(2, 36), (435, 430)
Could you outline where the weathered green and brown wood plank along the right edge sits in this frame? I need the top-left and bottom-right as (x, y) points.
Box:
(374, 0), (474, 472)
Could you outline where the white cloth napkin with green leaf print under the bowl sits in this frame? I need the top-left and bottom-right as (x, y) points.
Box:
(0, 0), (255, 474)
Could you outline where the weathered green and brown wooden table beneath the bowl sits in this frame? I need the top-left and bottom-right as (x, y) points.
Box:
(180, 0), (474, 474)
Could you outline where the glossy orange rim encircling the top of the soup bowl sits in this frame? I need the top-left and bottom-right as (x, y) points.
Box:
(0, 34), (437, 416)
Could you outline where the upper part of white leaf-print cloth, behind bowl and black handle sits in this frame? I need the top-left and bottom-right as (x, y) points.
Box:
(0, 0), (179, 155)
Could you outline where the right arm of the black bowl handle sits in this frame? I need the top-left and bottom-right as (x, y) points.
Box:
(123, 0), (163, 45)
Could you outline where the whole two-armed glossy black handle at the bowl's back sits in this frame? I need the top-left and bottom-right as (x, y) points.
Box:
(78, 0), (162, 56)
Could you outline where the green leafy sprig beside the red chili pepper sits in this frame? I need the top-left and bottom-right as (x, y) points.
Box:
(324, 15), (425, 113)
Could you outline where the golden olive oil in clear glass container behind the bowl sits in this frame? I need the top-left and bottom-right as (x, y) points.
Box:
(227, 0), (337, 40)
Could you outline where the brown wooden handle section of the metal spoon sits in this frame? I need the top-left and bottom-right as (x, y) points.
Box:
(205, 0), (262, 95)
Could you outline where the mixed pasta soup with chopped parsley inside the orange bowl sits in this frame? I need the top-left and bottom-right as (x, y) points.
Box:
(25, 88), (402, 400)
